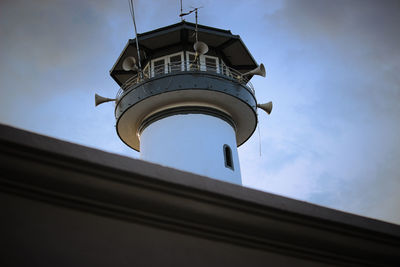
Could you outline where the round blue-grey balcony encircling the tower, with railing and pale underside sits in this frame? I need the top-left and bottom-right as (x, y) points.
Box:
(115, 62), (257, 151)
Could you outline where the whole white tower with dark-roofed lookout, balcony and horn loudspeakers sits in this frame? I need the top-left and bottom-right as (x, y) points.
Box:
(97, 21), (271, 184)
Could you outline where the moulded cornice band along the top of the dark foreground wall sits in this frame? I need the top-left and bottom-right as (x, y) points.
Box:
(0, 125), (400, 265)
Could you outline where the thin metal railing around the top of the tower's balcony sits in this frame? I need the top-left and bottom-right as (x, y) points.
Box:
(116, 62), (255, 102)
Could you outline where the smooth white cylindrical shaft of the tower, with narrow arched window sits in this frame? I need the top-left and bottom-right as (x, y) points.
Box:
(140, 111), (241, 184)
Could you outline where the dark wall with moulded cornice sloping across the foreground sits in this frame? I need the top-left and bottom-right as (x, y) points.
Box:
(0, 126), (400, 266)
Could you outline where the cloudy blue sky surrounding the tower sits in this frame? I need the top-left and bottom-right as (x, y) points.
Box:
(0, 0), (400, 224)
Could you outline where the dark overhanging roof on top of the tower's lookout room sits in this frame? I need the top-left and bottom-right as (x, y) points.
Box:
(110, 21), (258, 85)
